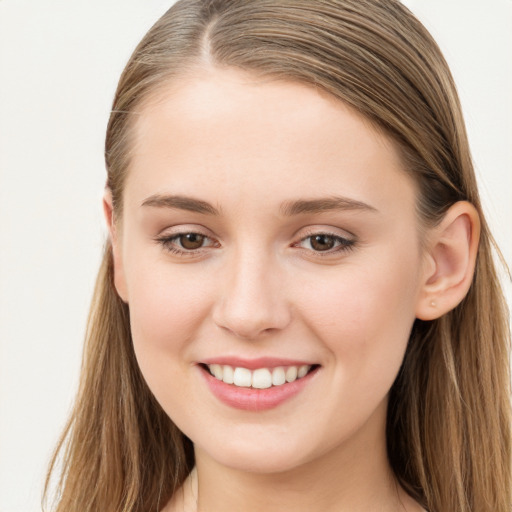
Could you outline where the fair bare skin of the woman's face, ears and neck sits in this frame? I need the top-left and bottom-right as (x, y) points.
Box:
(105, 69), (478, 512)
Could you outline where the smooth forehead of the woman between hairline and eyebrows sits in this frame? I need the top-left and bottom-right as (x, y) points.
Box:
(126, 66), (414, 216)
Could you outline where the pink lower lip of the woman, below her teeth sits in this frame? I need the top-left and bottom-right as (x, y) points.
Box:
(200, 368), (318, 411)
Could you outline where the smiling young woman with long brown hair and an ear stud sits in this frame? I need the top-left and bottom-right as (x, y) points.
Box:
(45, 0), (512, 512)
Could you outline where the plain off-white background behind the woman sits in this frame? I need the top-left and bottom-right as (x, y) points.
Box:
(0, 0), (512, 512)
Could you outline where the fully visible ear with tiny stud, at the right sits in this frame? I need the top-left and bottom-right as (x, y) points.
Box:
(416, 201), (480, 320)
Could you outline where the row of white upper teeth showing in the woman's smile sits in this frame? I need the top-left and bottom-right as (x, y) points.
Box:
(208, 364), (311, 389)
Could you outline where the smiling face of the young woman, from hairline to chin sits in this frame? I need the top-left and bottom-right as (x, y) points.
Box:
(113, 66), (430, 472)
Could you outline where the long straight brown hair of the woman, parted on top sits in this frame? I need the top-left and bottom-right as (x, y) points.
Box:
(47, 0), (512, 512)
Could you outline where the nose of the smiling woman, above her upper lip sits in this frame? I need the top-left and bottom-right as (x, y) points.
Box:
(213, 252), (291, 340)
